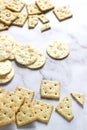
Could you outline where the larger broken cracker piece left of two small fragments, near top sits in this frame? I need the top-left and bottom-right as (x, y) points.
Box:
(28, 15), (38, 29)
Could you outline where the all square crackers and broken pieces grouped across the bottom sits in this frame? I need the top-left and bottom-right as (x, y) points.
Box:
(0, 80), (84, 126)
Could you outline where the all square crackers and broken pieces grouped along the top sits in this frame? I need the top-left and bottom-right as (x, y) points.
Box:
(0, 0), (73, 32)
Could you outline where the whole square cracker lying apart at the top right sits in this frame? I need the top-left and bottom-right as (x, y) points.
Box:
(53, 6), (73, 21)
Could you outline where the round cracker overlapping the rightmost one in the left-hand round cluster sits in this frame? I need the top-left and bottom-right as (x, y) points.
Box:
(15, 44), (36, 65)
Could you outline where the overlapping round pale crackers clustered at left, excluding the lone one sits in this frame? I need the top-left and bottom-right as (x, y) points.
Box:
(0, 34), (46, 84)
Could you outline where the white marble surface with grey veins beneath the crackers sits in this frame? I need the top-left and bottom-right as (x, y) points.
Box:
(0, 0), (87, 130)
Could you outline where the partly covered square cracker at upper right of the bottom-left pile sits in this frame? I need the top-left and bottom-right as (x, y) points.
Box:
(15, 86), (34, 101)
